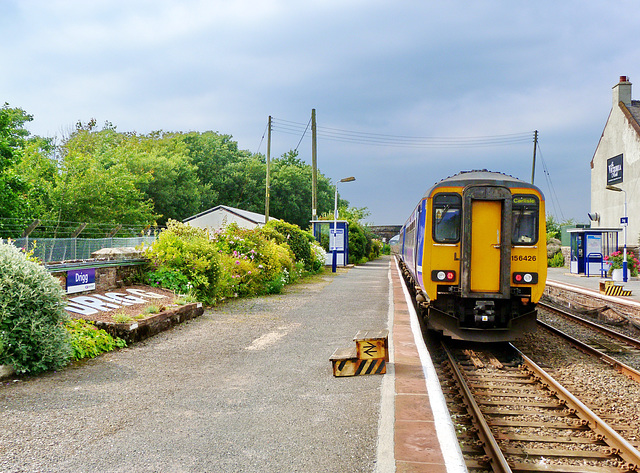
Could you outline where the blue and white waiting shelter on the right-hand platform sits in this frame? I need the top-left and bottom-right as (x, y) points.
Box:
(567, 228), (622, 277)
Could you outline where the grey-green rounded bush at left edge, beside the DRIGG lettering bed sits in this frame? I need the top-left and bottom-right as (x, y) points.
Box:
(0, 243), (71, 374)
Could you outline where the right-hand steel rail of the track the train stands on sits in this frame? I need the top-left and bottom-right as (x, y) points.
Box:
(510, 344), (640, 471)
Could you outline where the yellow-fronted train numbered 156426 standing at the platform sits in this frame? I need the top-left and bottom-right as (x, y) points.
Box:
(399, 170), (547, 342)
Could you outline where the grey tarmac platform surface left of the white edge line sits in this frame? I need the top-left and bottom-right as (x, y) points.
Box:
(0, 259), (388, 473)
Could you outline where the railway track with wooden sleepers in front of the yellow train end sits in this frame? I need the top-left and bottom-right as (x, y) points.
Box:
(434, 342), (640, 473)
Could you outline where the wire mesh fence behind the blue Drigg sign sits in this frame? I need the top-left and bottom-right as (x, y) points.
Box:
(0, 236), (156, 263)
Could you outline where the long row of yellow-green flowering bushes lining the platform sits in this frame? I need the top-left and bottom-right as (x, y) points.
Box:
(146, 220), (325, 305)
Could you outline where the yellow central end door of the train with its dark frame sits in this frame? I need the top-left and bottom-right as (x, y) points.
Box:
(460, 186), (512, 299)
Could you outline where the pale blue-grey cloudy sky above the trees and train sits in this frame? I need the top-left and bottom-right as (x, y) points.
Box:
(0, 0), (640, 225)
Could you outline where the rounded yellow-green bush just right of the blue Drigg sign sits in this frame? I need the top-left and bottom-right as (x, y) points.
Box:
(145, 220), (220, 304)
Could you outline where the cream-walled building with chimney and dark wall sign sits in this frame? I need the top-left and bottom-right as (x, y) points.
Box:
(590, 76), (640, 246)
